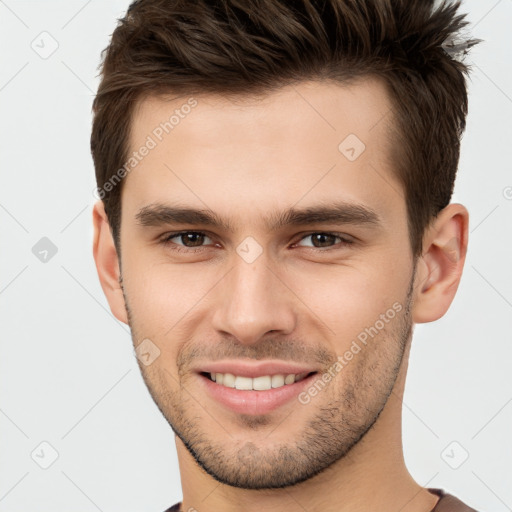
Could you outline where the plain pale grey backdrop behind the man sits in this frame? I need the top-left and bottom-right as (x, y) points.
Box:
(0, 0), (512, 512)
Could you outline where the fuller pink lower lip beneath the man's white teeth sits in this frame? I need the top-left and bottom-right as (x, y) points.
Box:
(199, 373), (316, 415)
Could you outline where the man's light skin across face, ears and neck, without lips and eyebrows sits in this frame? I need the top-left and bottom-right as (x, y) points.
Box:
(93, 79), (468, 512)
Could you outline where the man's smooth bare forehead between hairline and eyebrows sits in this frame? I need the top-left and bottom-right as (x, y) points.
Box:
(122, 78), (404, 226)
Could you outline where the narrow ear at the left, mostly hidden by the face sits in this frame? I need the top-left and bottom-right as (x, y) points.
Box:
(92, 201), (128, 324)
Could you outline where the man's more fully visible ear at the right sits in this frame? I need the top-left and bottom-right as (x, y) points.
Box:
(412, 203), (469, 323)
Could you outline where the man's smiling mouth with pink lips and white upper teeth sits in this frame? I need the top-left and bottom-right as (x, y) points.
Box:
(196, 362), (319, 415)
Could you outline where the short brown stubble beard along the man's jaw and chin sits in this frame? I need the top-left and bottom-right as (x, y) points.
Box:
(123, 273), (414, 489)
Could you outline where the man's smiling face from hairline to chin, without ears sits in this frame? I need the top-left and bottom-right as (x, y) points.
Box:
(116, 80), (414, 489)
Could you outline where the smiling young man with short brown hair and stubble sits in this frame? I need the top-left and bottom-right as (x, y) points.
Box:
(91, 0), (476, 512)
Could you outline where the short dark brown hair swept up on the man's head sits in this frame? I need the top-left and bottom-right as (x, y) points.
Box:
(91, 0), (479, 257)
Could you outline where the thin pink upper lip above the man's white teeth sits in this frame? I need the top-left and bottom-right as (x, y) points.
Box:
(196, 360), (318, 378)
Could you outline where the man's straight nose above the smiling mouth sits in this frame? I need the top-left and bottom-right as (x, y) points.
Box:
(213, 255), (297, 344)
